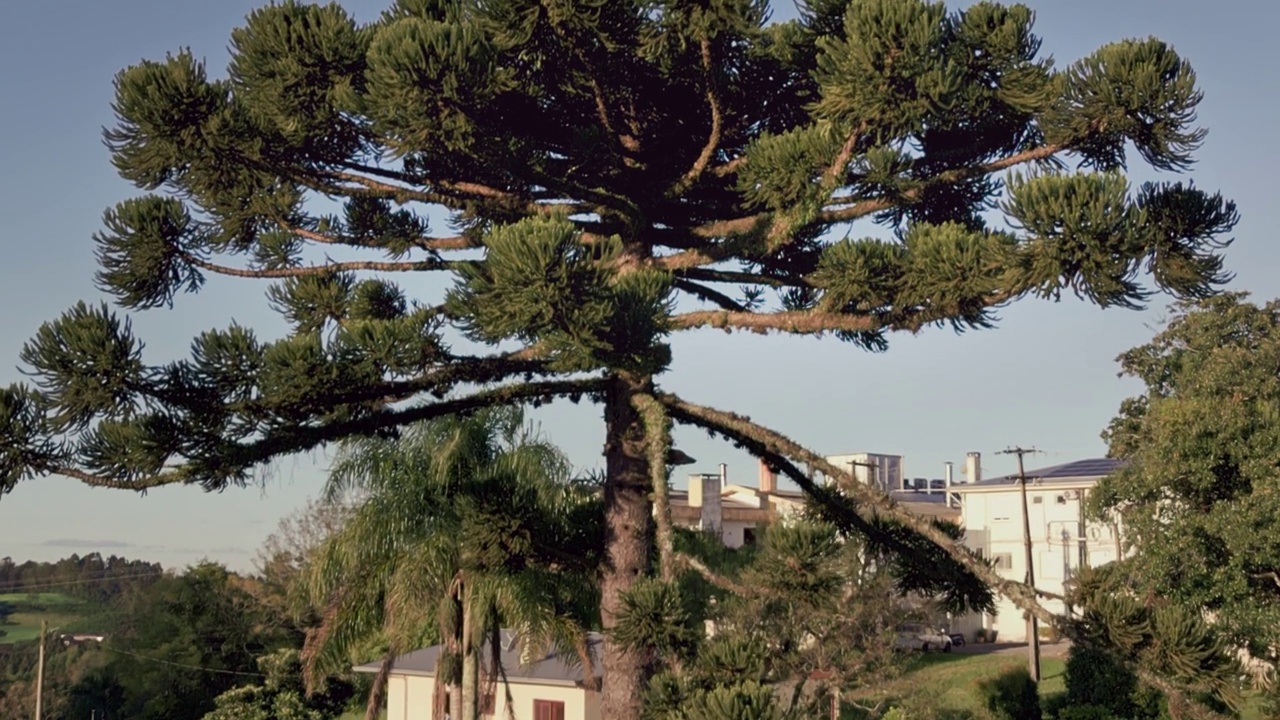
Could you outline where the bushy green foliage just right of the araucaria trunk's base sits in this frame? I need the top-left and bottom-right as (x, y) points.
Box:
(634, 521), (904, 720)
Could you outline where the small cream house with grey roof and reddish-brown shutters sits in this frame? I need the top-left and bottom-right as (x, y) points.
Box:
(355, 630), (603, 720)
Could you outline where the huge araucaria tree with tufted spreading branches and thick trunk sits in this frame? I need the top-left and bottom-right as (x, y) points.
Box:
(0, 0), (1235, 720)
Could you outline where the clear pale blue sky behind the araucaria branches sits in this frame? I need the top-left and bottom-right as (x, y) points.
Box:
(0, 0), (1280, 568)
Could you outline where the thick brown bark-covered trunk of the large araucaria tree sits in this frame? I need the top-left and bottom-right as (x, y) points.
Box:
(600, 374), (653, 720)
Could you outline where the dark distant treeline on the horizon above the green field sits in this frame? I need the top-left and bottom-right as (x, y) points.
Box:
(0, 552), (164, 602)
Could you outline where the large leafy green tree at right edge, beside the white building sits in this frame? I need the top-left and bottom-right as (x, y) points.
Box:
(1093, 293), (1280, 691)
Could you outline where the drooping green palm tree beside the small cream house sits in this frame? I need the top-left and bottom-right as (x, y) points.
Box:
(300, 409), (603, 720)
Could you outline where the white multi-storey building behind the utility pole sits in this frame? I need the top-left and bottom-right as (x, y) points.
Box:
(951, 457), (1123, 642)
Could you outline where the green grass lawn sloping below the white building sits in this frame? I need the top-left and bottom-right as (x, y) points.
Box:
(845, 652), (1065, 720)
